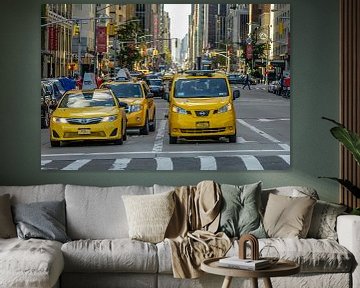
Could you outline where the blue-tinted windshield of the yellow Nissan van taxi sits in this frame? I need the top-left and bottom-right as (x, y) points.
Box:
(174, 78), (229, 98)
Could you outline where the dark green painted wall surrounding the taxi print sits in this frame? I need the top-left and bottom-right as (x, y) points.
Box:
(0, 0), (339, 202)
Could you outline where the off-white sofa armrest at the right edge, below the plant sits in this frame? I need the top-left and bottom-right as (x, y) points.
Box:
(336, 215), (360, 287)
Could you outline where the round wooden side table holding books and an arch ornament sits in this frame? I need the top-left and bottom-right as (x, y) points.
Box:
(201, 258), (300, 288)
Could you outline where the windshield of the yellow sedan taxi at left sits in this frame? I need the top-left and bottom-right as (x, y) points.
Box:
(59, 91), (116, 108)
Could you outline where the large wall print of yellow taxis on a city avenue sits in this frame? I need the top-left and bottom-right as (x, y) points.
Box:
(40, 3), (292, 171)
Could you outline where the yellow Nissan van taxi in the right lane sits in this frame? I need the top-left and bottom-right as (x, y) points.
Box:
(168, 70), (240, 144)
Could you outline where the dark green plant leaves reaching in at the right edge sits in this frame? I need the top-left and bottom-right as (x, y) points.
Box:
(320, 117), (360, 215)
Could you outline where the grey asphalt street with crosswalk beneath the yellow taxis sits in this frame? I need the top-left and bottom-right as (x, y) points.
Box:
(41, 84), (290, 171)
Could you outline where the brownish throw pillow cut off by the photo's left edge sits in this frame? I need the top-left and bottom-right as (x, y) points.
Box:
(0, 194), (16, 238)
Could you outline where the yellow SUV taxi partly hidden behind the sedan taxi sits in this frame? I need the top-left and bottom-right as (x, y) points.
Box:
(101, 81), (156, 135)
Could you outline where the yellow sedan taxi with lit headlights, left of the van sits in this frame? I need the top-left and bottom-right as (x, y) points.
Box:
(50, 89), (127, 147)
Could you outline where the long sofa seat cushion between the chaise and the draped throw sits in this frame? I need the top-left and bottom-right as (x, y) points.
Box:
(61, 239), (158, 273)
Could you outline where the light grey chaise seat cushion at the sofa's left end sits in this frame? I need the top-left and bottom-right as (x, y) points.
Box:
(0, 238), (64, 288)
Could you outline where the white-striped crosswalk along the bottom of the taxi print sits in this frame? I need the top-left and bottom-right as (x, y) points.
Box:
(41, 155), (290, 171)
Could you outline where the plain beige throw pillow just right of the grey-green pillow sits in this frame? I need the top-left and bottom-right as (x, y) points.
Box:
(264, 194), (316, 238)
